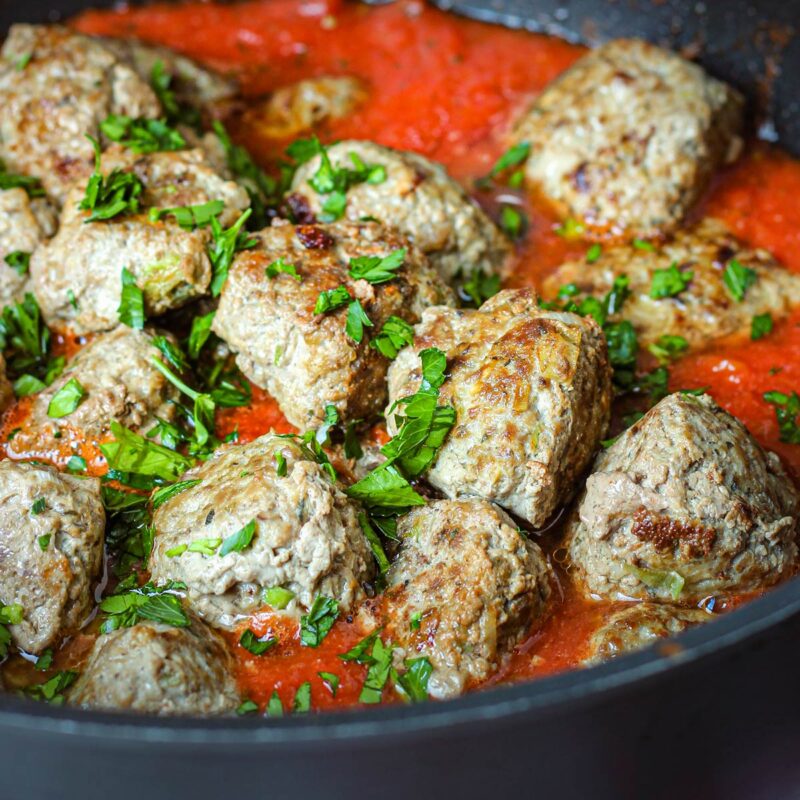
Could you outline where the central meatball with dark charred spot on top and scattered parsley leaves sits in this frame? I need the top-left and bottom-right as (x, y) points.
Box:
(213, 223), (454, 429)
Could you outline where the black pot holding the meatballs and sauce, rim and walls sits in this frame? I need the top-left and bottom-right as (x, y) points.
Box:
(0, 0), (800, 800)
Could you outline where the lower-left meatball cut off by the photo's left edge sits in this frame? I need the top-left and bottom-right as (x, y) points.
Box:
(0, 461), (106, 653)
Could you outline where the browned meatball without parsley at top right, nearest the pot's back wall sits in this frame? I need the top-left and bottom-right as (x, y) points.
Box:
(514, 39), (743, 236)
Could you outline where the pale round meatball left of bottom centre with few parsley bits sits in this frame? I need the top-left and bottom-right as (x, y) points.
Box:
(150, 435), (374, 627)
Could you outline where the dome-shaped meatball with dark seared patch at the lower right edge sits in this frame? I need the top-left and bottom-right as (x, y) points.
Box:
(567, 394), (800, 603)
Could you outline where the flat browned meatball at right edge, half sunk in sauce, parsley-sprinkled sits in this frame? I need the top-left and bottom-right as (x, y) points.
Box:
(544, 219), (800, 347)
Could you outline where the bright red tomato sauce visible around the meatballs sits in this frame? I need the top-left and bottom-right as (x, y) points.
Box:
(6, 0), (788, 709)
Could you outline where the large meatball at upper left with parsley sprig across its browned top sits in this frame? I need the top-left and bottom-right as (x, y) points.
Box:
(31, 146), (249, 333)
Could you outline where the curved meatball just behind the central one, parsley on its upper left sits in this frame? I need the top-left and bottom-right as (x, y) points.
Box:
(288, 141), (510, 281)
